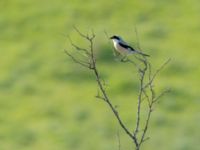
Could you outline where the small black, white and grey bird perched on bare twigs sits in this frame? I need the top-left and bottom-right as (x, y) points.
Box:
(110, 35), (149, 57)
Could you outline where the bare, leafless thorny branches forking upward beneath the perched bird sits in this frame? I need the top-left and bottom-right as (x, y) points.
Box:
(65, 27), (170, 150)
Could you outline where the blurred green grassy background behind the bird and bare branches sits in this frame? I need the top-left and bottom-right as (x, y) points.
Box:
(0, 0), (200, 150)
